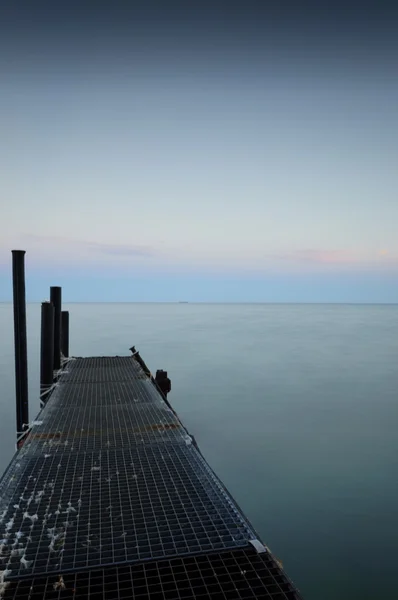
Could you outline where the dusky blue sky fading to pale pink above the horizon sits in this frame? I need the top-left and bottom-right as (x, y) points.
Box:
(0, 0), (398, 303)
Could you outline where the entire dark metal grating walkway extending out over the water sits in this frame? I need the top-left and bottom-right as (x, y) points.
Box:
(0, 357), (299, 600)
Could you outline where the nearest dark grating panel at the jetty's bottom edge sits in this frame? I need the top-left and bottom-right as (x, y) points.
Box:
(5, 549), (299, 600)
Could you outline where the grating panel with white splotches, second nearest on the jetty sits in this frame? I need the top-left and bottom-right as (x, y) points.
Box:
(2, 444), (254, 577)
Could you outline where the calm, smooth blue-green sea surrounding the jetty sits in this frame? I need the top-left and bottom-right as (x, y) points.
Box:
(0, 304), (398, 600)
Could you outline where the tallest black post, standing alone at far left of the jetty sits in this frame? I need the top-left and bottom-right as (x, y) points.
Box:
(12, 250), (29, 441)
